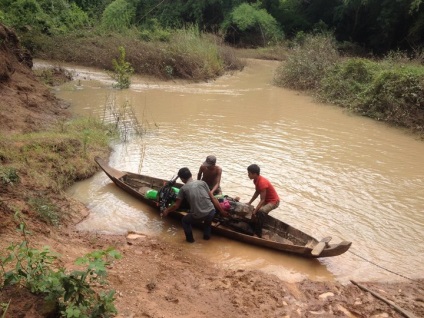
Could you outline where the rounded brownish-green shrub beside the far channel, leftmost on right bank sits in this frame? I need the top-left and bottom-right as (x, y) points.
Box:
(274, 34), (340, 90)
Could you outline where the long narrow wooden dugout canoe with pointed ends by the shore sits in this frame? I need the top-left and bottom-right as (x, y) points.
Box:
(95, 157), (352, 258)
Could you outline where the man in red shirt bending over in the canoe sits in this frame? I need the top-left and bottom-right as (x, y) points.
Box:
(247, 164), (280, 237)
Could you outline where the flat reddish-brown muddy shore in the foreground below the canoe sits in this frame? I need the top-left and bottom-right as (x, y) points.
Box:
(0, 225), (424, 318)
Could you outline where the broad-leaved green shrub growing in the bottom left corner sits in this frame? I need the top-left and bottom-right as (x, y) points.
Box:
(0, 215), (121, 318)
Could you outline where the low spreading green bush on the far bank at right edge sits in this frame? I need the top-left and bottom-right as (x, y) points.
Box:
(317, 53), (424, 132)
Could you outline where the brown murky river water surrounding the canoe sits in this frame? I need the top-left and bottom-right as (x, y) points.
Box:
(38, 60), (424, 281)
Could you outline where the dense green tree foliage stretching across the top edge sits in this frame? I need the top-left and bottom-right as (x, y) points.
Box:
(0, 0), (424, 54)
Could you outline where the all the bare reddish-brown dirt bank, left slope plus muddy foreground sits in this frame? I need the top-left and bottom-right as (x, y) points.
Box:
(0, 23), (424, 317)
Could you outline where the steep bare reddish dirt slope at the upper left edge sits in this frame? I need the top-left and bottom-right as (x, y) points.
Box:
(0, 24), (66, 133)
